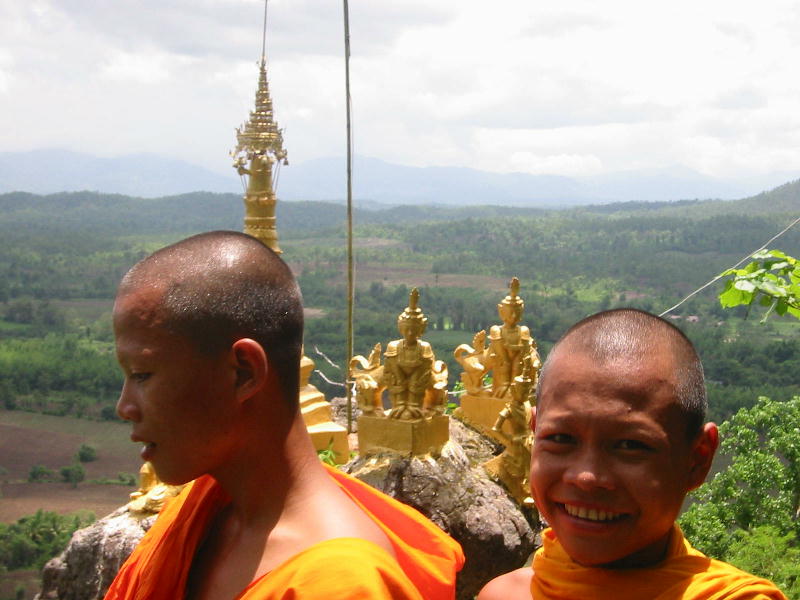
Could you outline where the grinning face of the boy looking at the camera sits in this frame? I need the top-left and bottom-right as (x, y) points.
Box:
(530, 347), (713, 567)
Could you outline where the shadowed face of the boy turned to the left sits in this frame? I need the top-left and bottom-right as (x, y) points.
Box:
(114, 289), (241, 484)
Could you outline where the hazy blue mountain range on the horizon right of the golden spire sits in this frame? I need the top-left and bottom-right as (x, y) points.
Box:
(279, 157), (800, 207)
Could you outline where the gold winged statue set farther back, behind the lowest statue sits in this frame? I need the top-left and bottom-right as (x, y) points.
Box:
(453, 277), (541, 441)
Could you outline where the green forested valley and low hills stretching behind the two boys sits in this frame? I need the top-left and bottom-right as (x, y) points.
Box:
(0, 182), (800, 426)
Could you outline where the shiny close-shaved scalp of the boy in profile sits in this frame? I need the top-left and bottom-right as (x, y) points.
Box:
(117, 231), (303, 404)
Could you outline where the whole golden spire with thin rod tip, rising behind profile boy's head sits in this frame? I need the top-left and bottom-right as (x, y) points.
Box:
(231, 0), (289, 253)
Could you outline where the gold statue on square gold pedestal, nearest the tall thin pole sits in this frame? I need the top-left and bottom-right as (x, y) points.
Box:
(350, 288), (449, 454)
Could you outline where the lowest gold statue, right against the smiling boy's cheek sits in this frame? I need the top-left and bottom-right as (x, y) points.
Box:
(485, 363), (533, 506)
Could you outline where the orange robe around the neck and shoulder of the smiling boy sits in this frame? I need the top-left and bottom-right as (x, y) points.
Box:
(531, 525), (786, 600)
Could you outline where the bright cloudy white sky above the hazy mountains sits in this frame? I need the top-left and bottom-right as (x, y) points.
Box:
(0, 0), (800, 178)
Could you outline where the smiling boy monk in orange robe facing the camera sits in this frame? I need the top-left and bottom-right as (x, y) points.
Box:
(478, 309), (784, 600)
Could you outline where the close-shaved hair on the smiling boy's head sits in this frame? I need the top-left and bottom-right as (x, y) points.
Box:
(539, 308), (707, 438)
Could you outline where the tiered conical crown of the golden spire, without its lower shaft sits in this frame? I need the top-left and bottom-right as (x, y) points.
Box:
(233, 57), (289, 165)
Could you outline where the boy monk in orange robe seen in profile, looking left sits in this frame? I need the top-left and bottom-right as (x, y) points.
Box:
(106, 232), (463, 600)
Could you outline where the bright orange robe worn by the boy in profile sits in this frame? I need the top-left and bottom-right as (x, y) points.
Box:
(106, 468), (464, 600)
